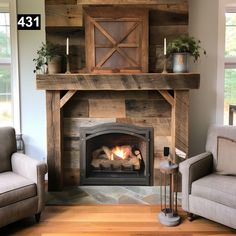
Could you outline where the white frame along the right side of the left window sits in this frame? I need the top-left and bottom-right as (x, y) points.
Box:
(0, 0), (21, 133)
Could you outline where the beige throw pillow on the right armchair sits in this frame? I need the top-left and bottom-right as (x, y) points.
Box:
(216, 137), (236, 175)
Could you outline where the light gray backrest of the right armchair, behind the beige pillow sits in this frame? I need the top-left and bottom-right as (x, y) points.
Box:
(206, 125), (236, 170)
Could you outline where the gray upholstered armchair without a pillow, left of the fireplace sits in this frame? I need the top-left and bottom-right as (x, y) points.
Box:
(0, 127), (47, 227)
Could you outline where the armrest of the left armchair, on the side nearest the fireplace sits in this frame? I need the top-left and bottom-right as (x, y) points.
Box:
(11, 153), (47, 213)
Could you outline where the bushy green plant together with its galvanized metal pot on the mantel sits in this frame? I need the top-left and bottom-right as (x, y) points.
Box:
(167, 35), (206, 73)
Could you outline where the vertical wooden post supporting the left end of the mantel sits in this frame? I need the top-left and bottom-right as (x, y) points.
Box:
(46, 90), (63, 191)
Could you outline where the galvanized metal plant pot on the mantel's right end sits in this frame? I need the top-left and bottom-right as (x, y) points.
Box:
(173, 53), (189, 73)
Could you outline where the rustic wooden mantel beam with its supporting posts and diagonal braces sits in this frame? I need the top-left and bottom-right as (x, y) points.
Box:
(36, 73), (200, 191)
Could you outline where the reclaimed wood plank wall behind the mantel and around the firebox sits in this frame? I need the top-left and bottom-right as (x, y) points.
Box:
(45, 0), (188, 185)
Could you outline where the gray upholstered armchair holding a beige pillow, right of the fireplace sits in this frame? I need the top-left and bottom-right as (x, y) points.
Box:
(180, 125), (236, 229)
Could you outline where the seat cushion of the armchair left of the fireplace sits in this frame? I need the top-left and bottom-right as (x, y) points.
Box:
(0, 171), (37, 207)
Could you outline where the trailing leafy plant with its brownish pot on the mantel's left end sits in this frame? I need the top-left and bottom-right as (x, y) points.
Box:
(33, 42), (61, 74)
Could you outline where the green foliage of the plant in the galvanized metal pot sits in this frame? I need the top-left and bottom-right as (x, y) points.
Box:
(167, 35), (206, 62)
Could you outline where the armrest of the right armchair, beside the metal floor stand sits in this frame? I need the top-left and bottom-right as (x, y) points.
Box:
(179, 152), (213, 211)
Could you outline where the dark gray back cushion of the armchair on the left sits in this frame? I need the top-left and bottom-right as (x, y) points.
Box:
(0, 127), (16, 173)
